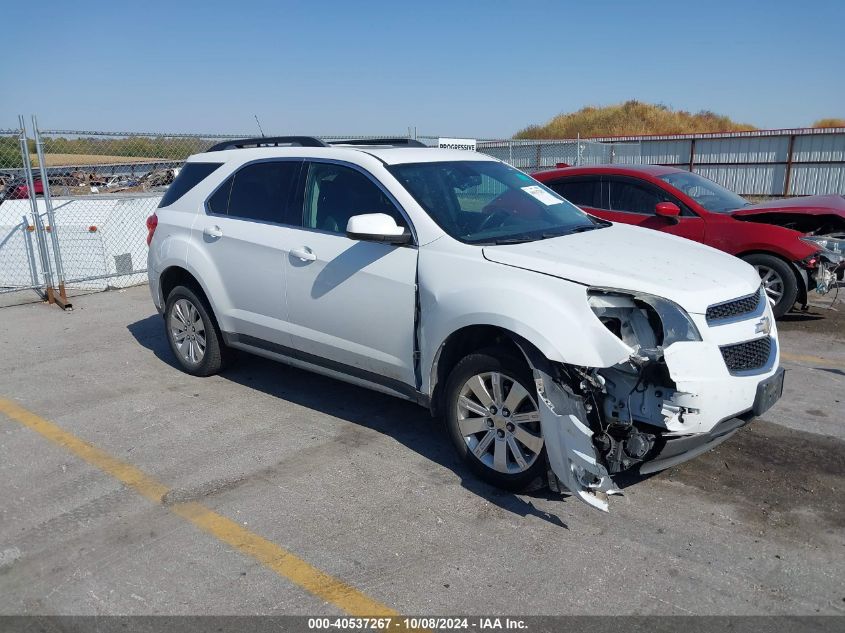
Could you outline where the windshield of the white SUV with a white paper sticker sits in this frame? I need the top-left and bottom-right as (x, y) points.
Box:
(389, 161), (609, 244)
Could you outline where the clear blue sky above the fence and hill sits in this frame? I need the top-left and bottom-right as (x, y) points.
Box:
(0, 0), (845, 137)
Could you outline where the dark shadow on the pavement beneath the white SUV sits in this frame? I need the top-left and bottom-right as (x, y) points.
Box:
(127, 315), (569, 529)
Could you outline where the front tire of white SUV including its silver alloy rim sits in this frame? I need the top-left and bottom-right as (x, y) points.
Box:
(443, 349), (546, 490)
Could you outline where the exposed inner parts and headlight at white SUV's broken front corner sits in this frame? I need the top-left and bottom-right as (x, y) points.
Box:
(535, 290), (700, 494)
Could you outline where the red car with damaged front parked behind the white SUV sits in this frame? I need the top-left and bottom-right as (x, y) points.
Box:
(532, 165), (845, 317)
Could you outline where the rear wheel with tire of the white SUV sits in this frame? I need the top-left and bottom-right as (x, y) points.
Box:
(164, 286), (232, 376)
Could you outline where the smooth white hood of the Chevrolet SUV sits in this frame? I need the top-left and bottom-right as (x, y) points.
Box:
(483, 224), (760, 314)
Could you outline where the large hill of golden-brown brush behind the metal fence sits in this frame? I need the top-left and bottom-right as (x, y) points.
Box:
(514, 100), (757, 139)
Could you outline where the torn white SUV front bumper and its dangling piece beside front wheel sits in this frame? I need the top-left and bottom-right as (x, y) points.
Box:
(534, 309), (784, 511)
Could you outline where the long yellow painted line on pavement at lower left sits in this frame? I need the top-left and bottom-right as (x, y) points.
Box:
(0, 398), (399, 616)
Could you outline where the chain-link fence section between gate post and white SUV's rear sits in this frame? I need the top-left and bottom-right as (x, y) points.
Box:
(29, 127), (242, 292)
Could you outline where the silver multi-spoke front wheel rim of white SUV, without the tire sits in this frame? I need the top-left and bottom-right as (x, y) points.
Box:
(456, 372), (543, 475)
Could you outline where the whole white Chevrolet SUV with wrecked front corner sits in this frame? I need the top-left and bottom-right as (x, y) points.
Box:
(148, 137), (783, 510)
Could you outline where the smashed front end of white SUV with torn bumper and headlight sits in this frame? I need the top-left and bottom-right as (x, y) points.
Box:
(529, 288), (783, 510)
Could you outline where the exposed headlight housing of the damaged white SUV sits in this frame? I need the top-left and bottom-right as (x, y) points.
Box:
(587, 288), (701, 353)
